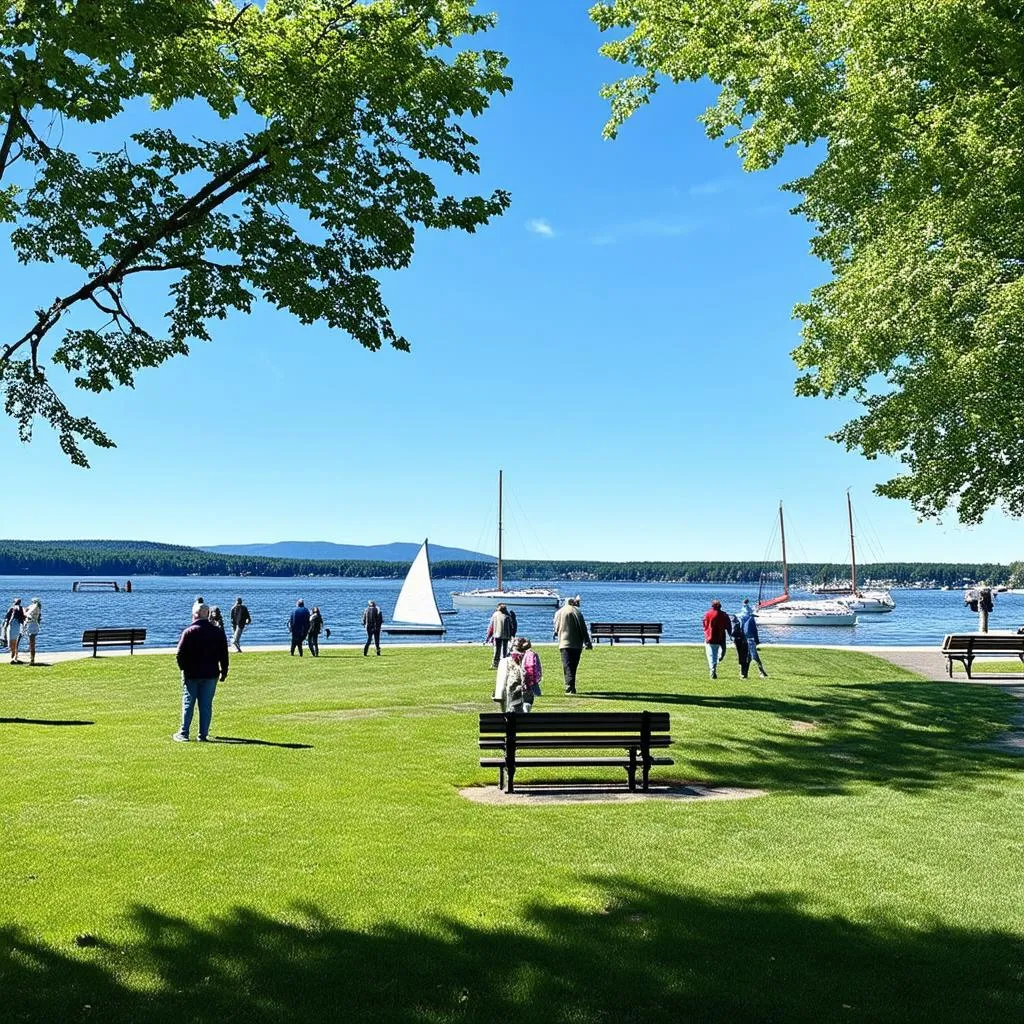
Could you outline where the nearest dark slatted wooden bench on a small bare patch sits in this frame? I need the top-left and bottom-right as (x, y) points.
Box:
(480, 711), (675, 793)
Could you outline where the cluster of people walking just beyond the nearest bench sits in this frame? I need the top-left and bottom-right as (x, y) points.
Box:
(485, 596), (593, 712)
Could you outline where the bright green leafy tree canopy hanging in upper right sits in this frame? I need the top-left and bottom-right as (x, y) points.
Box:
(591, 0), (1024, 522)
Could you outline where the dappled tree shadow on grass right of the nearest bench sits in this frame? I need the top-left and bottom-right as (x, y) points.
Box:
(586, 680), (1020, 795)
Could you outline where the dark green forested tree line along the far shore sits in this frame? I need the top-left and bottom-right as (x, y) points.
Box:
(0, 541), (1011, 587)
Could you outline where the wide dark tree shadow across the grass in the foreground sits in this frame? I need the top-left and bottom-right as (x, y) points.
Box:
(0, 880), (1024, 1024)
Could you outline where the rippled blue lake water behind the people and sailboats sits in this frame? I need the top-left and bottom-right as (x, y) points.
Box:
(0, 577), (1024, 650)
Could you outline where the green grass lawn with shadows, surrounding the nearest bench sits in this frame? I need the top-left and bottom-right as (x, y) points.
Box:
(0, 647), (1024, 1024)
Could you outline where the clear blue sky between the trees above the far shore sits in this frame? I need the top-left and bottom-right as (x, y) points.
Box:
(0, 0), (1021, 561)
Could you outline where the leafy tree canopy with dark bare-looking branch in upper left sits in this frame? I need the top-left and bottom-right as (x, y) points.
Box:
(0, 0), (511, 465)
